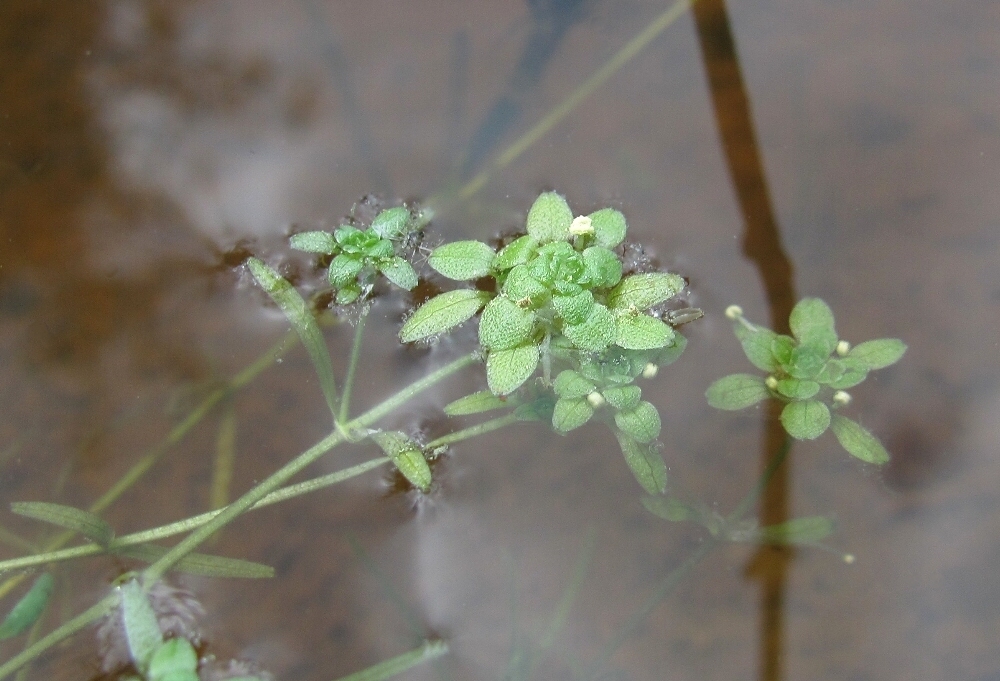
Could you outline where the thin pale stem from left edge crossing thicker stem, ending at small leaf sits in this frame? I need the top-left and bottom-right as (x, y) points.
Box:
(0, 456), (391, 572)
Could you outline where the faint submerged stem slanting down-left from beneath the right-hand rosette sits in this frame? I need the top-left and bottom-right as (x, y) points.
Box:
(584, 435), (792, 680)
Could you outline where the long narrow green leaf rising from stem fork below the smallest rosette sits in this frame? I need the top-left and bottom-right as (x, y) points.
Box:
(247, 258), (337, 414)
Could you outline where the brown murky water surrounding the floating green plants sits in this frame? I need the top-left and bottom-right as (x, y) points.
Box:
(0, 0), (1000, 681)
